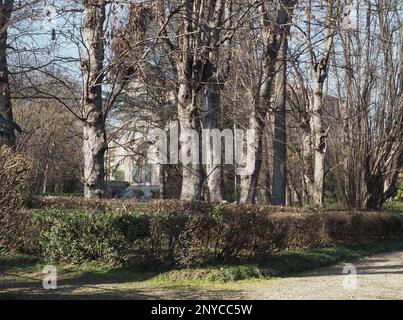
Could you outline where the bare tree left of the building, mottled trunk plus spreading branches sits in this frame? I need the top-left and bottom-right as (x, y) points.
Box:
(19, 0), (141, 198)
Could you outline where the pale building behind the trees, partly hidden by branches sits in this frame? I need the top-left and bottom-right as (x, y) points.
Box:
(105, 66), (175, 199)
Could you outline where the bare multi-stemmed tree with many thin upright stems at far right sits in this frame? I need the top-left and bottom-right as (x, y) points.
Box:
(316, 1), (402, 209)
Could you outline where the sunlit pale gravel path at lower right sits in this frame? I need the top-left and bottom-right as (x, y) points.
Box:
(247, 251), (403, 300)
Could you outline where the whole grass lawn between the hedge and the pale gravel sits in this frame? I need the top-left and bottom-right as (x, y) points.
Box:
(0, 241), (403, 299)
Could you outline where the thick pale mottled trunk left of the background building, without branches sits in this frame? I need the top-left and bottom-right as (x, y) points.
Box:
(82, 0), (107, 198)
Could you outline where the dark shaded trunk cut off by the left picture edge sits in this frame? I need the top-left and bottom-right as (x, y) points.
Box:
(0, 0), (15, 146)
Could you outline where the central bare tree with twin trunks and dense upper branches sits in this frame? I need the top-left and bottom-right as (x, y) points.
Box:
(159, 0), (241, 202)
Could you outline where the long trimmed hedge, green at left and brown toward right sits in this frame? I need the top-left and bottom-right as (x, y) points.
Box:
(25, 198), (403, 266)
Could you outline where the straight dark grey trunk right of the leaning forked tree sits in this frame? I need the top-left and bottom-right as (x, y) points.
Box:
(271, 37), (288, 206)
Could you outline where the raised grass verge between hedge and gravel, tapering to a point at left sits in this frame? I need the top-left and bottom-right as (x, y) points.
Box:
(147, 241), (403, 286)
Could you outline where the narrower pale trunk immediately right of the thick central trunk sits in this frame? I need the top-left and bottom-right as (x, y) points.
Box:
(203, 83), (224, 202)
